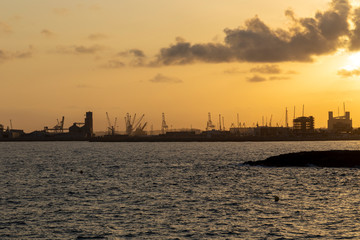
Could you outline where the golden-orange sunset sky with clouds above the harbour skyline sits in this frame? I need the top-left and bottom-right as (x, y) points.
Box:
(0, 0), (360, 132)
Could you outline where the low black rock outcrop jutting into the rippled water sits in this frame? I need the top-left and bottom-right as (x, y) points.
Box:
(244, 150), (360, 168)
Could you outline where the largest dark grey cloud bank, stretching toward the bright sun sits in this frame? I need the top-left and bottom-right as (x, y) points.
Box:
(149, 0), (354, 66)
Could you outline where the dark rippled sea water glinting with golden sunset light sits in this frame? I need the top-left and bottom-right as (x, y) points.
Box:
(0, 141), (360, 239)
